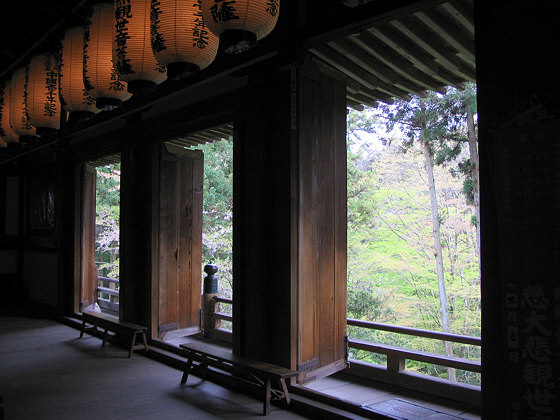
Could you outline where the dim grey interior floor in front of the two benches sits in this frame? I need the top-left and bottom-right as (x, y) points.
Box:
(0, 316), (305, 420)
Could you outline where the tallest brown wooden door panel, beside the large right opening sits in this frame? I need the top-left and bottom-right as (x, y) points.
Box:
(293, 66), (346, 381)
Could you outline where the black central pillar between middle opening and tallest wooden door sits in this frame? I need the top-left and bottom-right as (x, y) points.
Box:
(233, 72), (294, 366)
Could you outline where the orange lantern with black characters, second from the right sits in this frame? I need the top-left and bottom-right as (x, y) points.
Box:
(151, 0), (219, 80)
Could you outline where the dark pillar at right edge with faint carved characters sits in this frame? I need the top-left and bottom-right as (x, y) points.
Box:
(475, 1), (560, 419)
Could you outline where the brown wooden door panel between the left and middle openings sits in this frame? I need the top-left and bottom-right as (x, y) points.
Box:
(153, 145), (204, 339)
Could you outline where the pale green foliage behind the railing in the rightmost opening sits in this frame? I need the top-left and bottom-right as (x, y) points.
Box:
(347, 97), (480, 384)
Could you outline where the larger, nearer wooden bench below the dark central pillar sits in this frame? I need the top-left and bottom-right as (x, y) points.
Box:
(180, 342), (298, 416)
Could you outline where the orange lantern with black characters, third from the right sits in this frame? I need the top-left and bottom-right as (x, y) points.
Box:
(113, 0), (167, 94)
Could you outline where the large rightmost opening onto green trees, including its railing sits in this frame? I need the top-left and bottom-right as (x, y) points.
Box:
(347, 83), (481, 385)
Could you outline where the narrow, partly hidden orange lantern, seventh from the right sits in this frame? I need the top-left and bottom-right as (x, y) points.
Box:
(10, 66), (37, 143)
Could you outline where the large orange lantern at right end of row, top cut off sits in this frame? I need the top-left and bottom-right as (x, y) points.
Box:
(202, 0), (280, 54)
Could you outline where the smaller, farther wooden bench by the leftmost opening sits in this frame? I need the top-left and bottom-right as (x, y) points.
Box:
(80, 312), (148, 357)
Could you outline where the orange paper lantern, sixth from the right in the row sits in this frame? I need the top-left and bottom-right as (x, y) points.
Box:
(27, 53), (62, 135)
